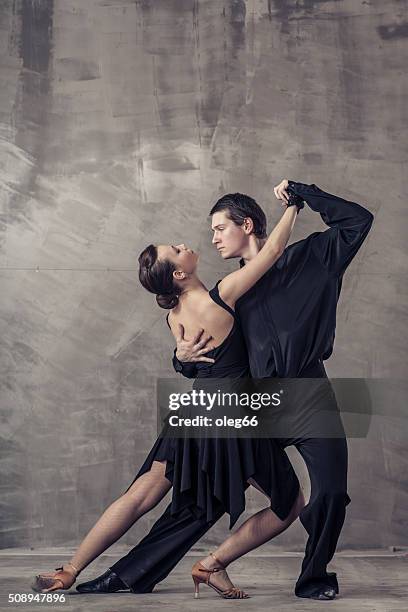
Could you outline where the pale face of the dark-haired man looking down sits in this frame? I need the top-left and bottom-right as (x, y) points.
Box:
(211, 210), (248, 259)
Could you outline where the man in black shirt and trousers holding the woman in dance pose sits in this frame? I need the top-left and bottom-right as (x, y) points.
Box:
(77, 180), (373, 600)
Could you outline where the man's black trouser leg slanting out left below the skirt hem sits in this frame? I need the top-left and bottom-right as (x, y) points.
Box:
(110, 504), (223, 593)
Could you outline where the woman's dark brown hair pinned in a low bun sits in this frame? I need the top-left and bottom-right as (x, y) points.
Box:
(139, 244), (180, 309)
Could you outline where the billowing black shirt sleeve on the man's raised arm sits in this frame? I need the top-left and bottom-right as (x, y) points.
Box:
(288, 181), (374, 275)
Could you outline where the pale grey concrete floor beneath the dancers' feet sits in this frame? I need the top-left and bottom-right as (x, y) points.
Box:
(0, 549), (408, 612)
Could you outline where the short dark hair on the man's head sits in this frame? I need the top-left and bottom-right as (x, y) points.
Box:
(210, 193), (266, 238)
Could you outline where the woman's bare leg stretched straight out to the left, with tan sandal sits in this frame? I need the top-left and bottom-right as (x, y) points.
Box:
(32, 461), (172, 591)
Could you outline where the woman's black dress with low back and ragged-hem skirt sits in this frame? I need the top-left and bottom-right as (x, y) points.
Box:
(127, 283), (299, 529)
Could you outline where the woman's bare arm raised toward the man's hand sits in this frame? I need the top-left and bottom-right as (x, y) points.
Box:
(218, 194), (298, 306)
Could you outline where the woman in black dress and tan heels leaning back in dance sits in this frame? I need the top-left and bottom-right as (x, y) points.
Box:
(33, 185), (304, 599)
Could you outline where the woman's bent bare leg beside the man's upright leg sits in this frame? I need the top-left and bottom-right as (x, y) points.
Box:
(196, 479), (305, 589)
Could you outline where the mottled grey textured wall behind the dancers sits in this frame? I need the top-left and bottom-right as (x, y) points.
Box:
(0, 0), (408, 550)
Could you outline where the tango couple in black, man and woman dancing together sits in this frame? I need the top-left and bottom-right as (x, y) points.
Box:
(33, 179), (373, 600)
